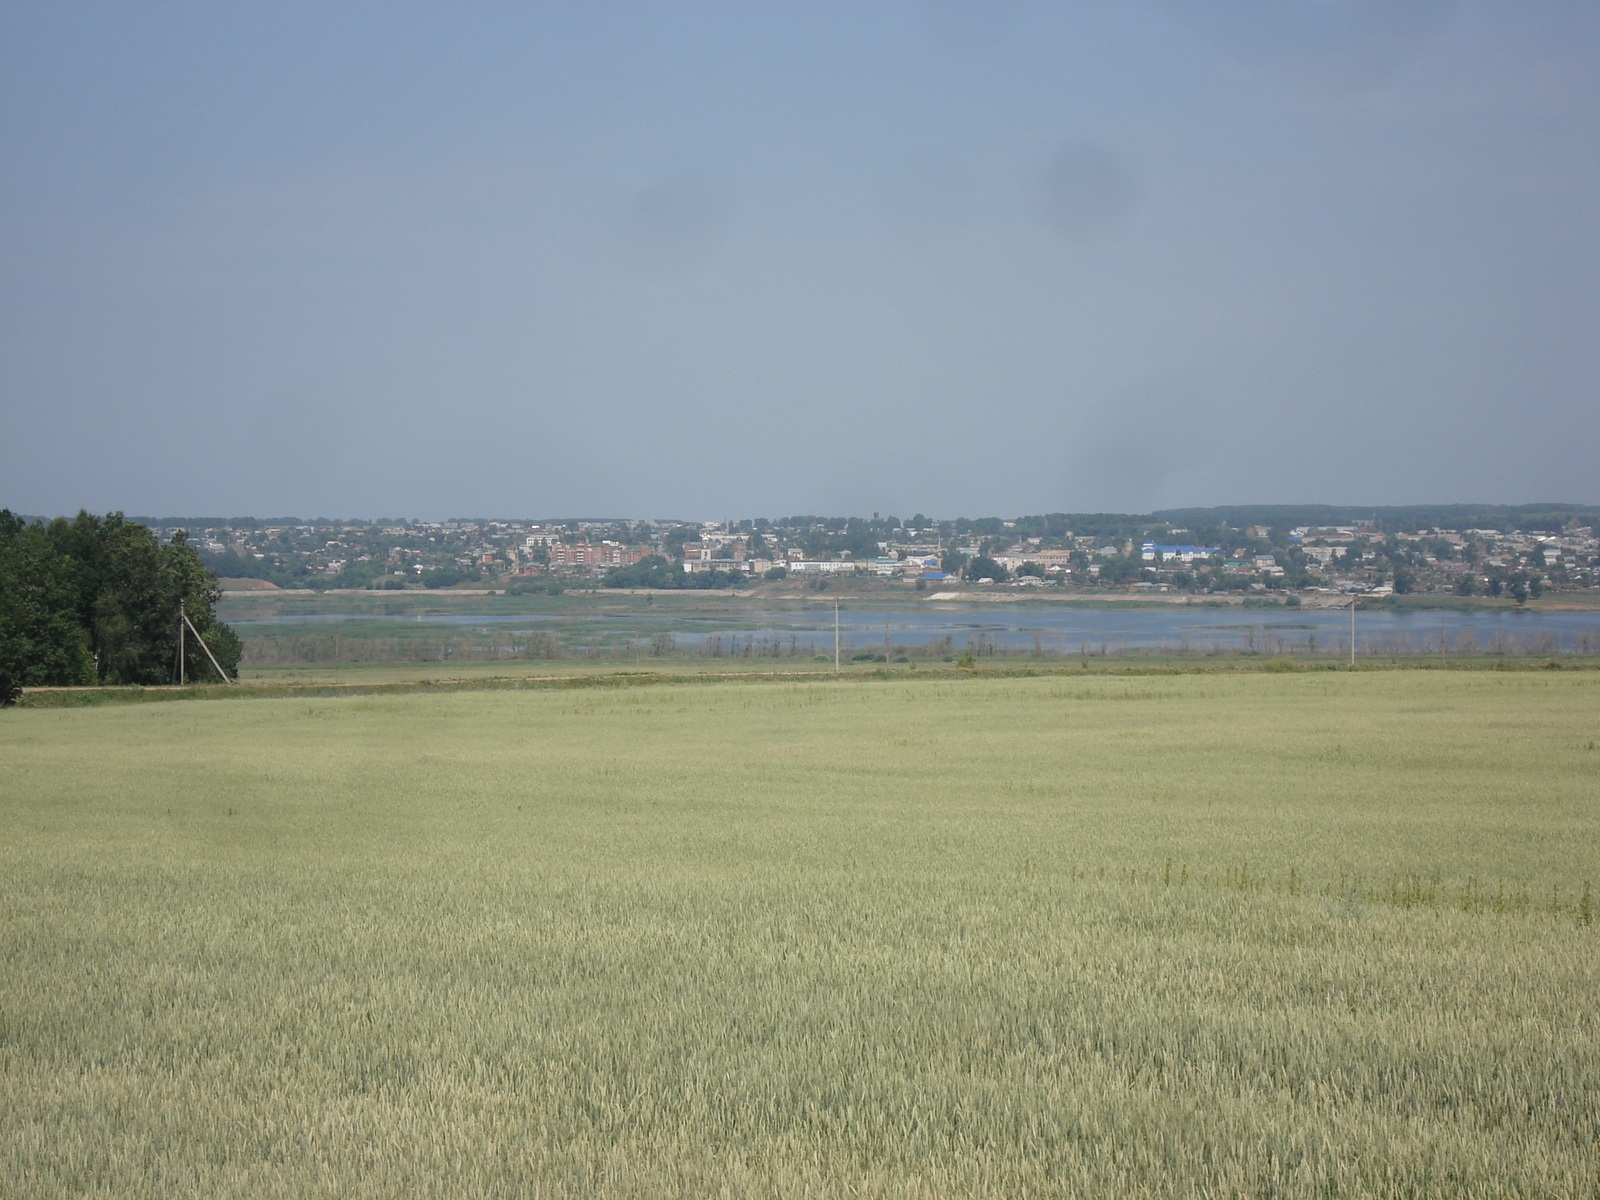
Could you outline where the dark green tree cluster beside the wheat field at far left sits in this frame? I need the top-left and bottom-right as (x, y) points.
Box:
(0, 509), (242, 702)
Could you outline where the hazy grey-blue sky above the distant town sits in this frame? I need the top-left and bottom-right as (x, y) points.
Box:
(0, 0), (1600, 518)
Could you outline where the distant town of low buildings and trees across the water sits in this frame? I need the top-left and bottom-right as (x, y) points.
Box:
(112, 506), (1600, 602)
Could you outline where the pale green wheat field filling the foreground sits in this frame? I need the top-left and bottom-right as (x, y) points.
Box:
(0, 670), (1600, 1200)
